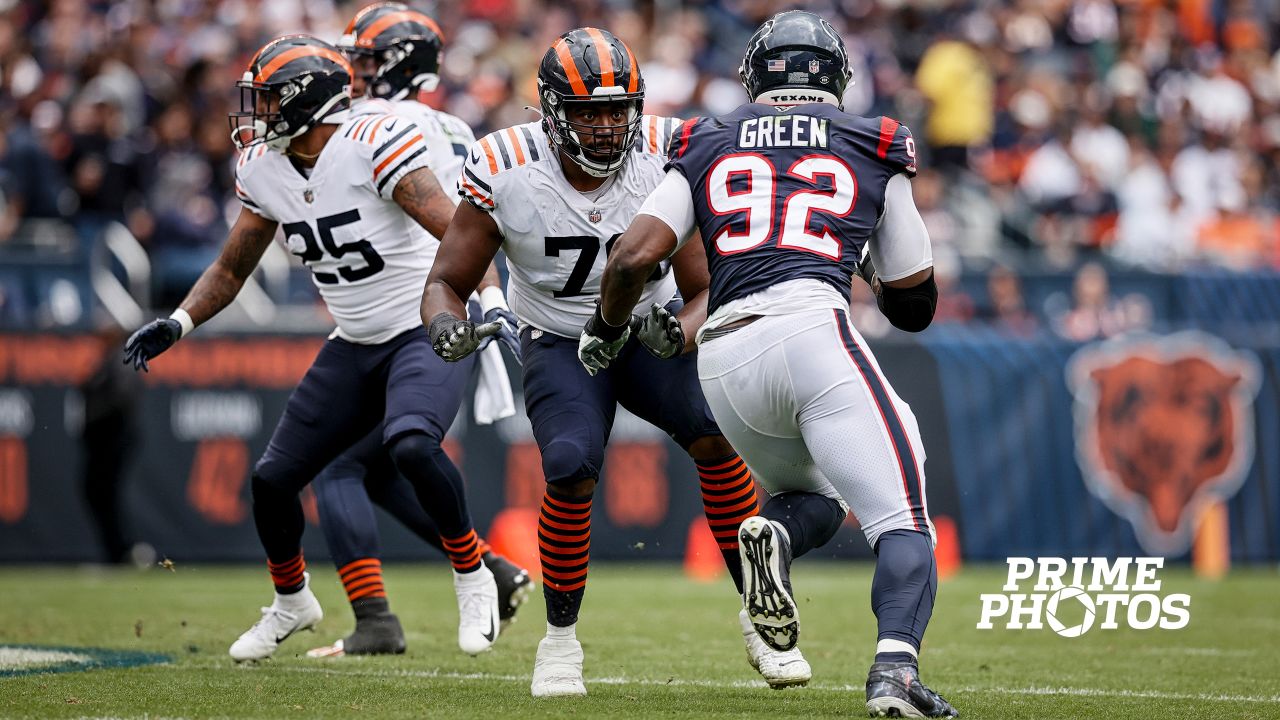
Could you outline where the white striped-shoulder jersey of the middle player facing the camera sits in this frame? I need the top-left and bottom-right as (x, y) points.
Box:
(458, 115), (680, 338)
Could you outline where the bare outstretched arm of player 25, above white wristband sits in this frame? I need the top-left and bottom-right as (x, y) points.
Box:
(179, 210), (275, 325)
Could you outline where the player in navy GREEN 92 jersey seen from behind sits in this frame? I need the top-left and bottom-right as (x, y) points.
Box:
(579, 12), (956, 717)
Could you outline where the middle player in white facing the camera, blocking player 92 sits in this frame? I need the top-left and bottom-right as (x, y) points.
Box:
(422, 27), (809, 697)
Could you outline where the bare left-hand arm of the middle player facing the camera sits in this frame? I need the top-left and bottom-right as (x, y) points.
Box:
(421, 196), (502, 319)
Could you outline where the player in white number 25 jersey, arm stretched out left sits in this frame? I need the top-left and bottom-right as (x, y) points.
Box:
(124, 35), (498, 661)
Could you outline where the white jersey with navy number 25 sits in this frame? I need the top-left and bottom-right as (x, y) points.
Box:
(236, 113), (440, 345)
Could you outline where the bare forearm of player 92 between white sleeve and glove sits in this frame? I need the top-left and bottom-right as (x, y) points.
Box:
(600, 215), (676, 325)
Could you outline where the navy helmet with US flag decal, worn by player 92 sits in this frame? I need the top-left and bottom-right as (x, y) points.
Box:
(737, 10), (852, 106)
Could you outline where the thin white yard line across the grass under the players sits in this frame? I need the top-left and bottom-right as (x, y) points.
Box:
(241, 661), (1280, 705)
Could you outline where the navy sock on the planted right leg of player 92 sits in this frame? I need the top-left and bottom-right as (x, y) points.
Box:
(872, 530), (938, 662)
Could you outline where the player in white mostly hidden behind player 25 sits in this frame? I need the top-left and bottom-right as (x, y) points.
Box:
(307, 3), (532, 657)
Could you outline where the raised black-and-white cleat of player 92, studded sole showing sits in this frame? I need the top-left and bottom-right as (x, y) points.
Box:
(737, 515), (800, 652)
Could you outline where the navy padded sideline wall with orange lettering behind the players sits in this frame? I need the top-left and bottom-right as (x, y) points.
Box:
(0, 319), (1280, 562)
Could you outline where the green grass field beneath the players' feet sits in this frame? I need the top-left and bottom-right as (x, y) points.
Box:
(0, 562), (1280, 720)
